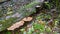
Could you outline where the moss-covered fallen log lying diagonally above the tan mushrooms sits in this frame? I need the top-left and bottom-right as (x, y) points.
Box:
(0, 1), (43, 31)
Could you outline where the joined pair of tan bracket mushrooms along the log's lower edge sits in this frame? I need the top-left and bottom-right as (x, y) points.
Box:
(7, 17), (33, 30)
